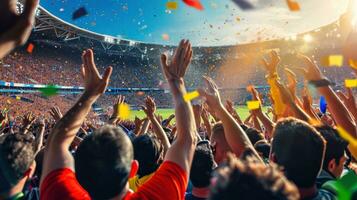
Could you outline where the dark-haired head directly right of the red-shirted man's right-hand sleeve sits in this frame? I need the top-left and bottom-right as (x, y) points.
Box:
(190, 140), (215, 188)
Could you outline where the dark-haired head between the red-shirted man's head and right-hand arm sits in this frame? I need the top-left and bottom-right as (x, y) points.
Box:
(133, 134), (162, 177)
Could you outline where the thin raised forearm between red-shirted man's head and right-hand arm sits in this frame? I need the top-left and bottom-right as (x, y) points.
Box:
(141, 96), (171, 155)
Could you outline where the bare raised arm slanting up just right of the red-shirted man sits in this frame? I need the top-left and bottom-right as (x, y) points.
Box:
(198, 77), (259, 159)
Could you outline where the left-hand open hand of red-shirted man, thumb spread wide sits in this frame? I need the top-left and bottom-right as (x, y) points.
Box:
(81, 49), (113, 97)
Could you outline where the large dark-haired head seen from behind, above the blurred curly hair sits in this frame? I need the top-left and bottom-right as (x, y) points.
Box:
(270, 118), (325, 188)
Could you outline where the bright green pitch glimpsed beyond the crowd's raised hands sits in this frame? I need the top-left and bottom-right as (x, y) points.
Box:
(130, 106), (266, 120)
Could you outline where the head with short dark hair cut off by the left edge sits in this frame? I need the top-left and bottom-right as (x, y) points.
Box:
(0, 133), (36, 195)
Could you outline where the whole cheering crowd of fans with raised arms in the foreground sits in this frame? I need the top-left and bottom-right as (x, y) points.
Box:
(0, 0), (357, 200)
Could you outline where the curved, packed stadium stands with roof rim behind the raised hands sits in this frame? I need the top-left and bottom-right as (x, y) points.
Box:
(0, 1), (353, 120)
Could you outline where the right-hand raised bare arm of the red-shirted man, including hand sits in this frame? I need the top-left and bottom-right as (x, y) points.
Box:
(161, 40), (197, 174)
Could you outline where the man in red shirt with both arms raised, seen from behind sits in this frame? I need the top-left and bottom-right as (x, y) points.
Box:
(40, 40), (197, 200)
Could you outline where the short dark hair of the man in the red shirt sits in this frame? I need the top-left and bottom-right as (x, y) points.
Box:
(75, 125), (133, 199)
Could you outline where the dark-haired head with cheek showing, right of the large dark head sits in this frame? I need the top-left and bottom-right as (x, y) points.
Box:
(316, 126), (348, 178)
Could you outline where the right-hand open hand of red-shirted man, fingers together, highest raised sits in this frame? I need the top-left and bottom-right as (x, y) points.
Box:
(161, 40), (192, 81)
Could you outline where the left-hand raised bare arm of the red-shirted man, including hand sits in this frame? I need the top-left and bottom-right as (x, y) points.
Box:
(42, 50), (112, 182)
